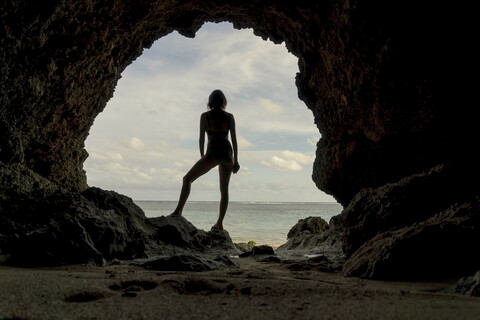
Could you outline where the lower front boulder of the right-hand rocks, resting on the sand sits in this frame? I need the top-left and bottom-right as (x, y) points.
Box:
(343, 198), (480, 280)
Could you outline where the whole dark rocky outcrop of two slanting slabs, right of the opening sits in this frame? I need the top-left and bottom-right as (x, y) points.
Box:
(339, 167), (480, 279)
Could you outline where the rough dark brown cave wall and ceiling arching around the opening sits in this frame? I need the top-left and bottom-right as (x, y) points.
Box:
(0, 0), (480, 205)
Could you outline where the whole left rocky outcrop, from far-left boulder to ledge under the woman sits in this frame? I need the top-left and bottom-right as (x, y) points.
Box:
(0, 188), (239, 270)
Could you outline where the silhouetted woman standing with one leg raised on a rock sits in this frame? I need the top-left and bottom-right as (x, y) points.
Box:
(171, 90), (240, 230)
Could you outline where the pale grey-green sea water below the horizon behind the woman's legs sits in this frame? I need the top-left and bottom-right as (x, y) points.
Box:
(135, 201), (342, 247)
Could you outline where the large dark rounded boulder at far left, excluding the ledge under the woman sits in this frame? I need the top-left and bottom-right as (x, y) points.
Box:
(0, 188), (158, 266)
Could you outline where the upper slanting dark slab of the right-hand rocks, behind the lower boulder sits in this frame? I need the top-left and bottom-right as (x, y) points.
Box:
(339, 165), (474, 255)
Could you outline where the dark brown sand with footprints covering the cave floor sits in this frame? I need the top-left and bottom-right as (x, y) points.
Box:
(0, 258), (480, 319)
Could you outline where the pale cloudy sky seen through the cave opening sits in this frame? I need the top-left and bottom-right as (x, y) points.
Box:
(84, 23), (335, 202)
